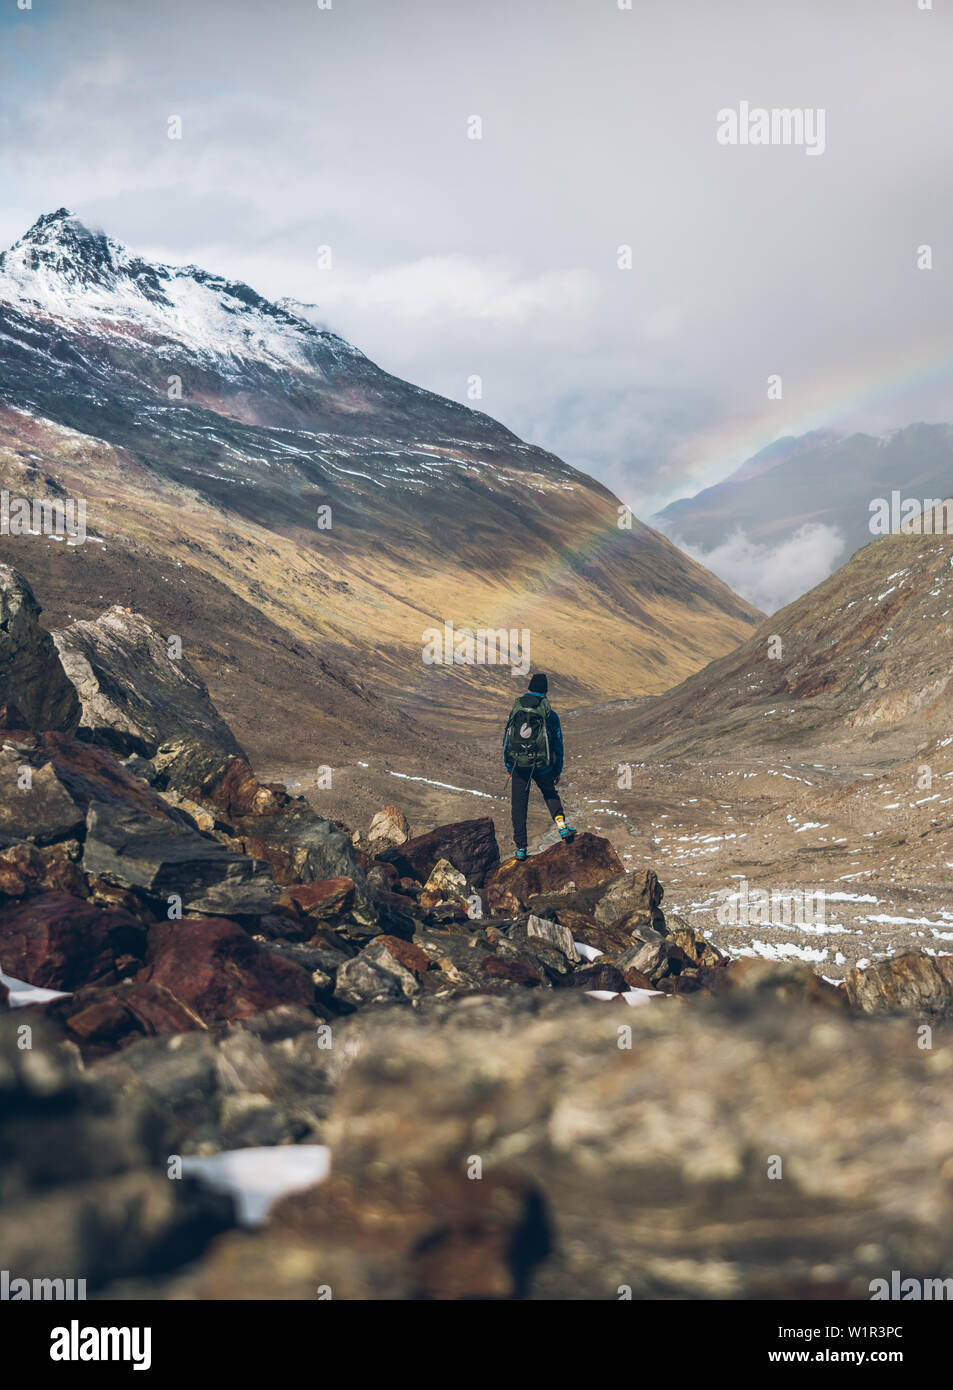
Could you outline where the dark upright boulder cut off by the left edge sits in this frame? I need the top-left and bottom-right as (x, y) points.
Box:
(0, 564), (79, 731)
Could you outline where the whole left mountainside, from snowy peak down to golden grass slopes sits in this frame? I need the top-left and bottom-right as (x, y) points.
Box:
(0, 209), (756, 762)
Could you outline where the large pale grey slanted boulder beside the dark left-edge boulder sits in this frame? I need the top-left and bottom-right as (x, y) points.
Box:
(53, 607), (242, 758)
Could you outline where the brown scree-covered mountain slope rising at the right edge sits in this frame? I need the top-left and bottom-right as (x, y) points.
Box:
(605, 500), (953, 759)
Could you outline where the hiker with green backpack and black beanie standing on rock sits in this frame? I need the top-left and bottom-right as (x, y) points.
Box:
(503, 673), (575, 859)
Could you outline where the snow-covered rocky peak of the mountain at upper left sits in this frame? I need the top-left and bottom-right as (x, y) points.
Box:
(0, 207), (363, 370)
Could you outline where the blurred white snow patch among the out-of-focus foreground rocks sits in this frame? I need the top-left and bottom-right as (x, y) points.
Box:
(182, 1144), (331, 1226)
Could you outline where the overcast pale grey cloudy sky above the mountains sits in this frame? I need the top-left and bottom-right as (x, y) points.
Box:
(0, 0), (953, 516)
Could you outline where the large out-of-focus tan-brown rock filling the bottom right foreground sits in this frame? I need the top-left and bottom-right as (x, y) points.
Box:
(136, 992), (953, 1300)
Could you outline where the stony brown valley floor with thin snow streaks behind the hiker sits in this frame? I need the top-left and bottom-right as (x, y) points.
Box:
(261, 710), (953, 981)
